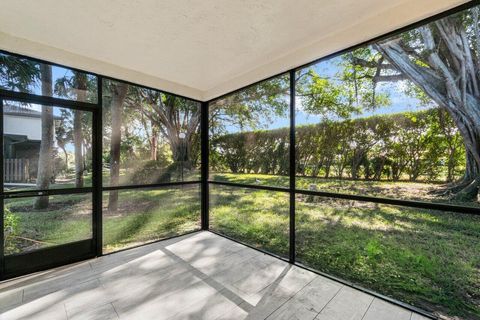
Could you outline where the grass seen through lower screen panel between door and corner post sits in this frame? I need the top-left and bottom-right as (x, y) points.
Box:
(103, 186), (200, 252)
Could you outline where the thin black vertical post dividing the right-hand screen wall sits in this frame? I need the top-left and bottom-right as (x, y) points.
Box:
(289, 70), (296, 263)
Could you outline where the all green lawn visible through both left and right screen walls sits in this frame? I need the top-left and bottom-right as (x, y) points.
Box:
(5, 175), (480, 319)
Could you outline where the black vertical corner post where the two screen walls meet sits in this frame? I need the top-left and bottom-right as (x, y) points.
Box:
(200, 102), (209, 230)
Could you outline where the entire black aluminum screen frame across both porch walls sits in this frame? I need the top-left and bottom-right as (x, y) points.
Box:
(0, 0), (480, 319)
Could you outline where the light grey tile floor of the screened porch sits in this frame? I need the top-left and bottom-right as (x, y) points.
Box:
(0, 232), (427, 320)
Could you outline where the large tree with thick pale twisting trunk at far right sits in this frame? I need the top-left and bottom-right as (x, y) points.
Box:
(360, 7), (480, 200)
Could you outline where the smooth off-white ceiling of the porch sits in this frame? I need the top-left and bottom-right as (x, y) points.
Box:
(0, 0), (467, 100)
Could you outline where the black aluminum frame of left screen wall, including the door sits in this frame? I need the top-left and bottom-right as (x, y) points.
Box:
(0, 58), (202, 280)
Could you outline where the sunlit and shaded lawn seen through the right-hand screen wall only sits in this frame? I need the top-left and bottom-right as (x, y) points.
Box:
(210, 175), (480, 319)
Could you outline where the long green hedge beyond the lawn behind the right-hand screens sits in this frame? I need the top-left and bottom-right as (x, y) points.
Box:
(210, 109), (465, 182)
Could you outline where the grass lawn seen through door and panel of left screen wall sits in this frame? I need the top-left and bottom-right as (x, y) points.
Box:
(5, 185), (200, 254)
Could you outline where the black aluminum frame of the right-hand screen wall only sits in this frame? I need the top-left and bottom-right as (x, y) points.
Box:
(202, 0), (480, 319)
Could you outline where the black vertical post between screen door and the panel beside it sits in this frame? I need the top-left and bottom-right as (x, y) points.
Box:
(92, 76), (103, 256)
